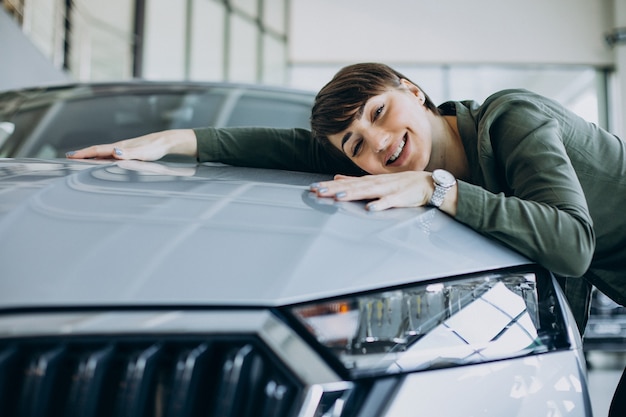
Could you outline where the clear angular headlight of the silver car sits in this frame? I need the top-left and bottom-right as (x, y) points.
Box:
(290, 272), (569, 377)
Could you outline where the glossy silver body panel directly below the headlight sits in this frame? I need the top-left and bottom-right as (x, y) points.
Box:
(383, 352), (591, 417)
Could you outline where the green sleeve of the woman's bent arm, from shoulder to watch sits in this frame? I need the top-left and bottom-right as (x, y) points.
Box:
(457, 100), (595, 277)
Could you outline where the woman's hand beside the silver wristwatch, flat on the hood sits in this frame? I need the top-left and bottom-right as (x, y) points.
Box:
(311, 171), (434, 211)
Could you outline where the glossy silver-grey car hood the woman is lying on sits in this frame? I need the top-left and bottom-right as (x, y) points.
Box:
(0, 159), (529, 308)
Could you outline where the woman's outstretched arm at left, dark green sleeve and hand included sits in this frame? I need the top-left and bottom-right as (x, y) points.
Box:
(67, 127), (364, 175)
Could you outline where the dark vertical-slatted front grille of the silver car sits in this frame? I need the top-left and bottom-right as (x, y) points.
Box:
(0, 335), (302, 417)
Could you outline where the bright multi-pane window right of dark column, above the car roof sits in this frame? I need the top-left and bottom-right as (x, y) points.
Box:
(141, 0), (289, 84)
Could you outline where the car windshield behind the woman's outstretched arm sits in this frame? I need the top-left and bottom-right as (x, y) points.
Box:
(0, 83), (312, 158)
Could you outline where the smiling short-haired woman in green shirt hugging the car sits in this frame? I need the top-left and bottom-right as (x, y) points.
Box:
(68, 63), (626, 415)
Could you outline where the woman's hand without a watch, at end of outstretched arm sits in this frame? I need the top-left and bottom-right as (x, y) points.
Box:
(66, 129), (198, 161)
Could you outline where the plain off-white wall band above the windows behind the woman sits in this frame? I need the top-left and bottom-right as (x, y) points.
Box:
(290, 0), (612, 66)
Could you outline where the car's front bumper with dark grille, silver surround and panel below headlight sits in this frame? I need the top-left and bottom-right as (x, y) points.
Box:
(0, 309), (591, 417)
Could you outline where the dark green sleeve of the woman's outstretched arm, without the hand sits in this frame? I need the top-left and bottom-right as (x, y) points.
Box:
(194, 127), (365, 175)
